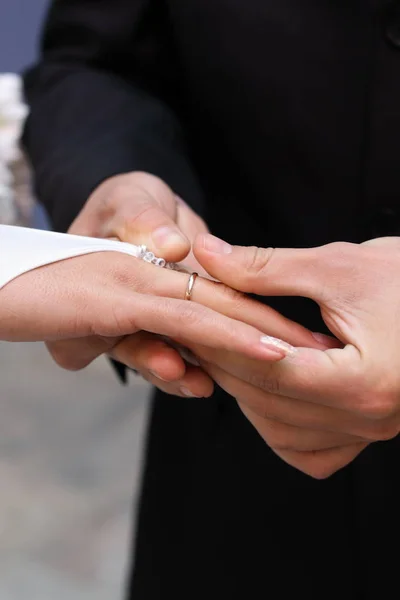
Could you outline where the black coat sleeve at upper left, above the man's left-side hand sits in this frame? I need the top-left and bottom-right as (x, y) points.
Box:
(24, 0), (202, 230)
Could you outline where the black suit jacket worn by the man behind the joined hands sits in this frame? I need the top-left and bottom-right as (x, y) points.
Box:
(25, 0), (400, 600)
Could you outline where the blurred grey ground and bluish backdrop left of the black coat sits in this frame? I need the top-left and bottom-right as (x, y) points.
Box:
(0, 0), (149, 600)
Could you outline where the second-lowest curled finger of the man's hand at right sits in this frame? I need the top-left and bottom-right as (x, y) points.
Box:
(239, 403), (363, 452)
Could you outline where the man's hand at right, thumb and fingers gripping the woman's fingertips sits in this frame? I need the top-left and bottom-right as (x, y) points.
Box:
(194, 235), (400, 477)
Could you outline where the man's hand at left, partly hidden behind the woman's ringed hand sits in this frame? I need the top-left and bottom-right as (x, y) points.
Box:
(48, 173), (213, 396)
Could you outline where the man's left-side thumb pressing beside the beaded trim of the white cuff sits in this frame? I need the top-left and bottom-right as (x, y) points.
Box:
(102, 175), (190, 262)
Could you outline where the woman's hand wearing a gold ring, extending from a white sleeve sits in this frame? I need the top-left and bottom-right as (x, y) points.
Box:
(0, 246), (322, 395)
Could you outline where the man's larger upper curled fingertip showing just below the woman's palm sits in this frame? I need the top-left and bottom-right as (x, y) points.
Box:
(109, 331), (186, 382)
